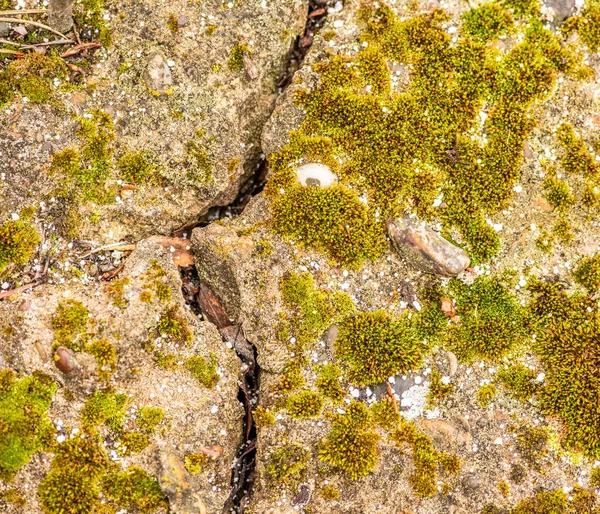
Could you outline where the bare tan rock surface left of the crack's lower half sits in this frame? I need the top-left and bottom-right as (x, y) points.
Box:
(0, 242), (243, 514)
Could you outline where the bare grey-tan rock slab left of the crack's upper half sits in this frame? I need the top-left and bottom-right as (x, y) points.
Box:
(0, 0), (306, 242)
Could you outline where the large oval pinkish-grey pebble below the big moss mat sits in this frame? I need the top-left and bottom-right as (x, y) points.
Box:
(388, 218), (470, 276)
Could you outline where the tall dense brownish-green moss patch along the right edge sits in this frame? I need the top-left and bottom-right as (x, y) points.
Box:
(530, 281), (600, 459)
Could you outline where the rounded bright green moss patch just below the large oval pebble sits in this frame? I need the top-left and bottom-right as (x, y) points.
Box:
(446, 275), (528, 362)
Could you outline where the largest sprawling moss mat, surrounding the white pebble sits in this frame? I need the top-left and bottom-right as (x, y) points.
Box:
(265, 2), (581, 266)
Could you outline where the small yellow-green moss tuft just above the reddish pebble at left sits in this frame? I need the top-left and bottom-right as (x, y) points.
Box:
(51, 300), (90, 352)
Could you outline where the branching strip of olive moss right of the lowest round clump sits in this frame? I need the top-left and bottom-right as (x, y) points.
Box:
(390, 419), (460, 496)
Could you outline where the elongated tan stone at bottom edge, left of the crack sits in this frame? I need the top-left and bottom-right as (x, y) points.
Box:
(159, 450), (206, 514)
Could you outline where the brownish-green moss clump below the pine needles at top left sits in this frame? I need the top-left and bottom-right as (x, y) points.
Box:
(0, 52), (69, 107)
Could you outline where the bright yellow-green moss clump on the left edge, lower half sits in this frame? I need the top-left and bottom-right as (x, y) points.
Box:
(0, 369), (57, 480)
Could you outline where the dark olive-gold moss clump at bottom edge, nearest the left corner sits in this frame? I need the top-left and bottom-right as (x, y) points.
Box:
(38, 437), (109, 514)
